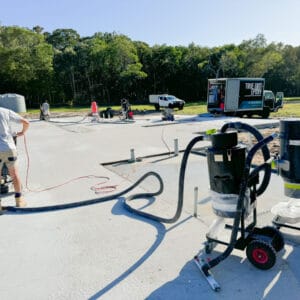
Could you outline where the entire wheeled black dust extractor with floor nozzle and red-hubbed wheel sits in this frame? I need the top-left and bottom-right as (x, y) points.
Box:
(194, 123), (284, 291)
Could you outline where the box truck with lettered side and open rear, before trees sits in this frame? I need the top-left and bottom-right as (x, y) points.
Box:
(207, 78), (283, 118)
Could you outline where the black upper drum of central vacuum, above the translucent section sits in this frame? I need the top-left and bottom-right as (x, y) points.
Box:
(207, 132), (246, 194)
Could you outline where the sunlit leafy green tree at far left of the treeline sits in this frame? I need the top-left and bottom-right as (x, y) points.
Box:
(0, 26), (53, 105)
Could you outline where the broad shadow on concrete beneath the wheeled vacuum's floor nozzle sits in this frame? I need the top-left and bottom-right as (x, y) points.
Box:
(146, 244), (300, 300)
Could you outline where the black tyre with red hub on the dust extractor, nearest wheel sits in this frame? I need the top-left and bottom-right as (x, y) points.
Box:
(246, 240), (276, 270)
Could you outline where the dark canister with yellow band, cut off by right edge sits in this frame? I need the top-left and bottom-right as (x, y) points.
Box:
(279, 119), (300, 198)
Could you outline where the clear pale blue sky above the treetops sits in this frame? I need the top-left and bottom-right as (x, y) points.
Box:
(0, 0), (300, 47)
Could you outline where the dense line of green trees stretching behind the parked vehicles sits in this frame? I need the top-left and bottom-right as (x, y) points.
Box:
(0, 26), (300, 107)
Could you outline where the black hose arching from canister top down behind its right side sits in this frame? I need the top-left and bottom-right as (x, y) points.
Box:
(221, 122), (272, 196)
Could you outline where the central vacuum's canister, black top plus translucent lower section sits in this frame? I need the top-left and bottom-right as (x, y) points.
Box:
(207, 132), (250, 218)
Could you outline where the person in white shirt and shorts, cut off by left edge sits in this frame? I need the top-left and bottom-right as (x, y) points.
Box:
(0, 107), (29, 207)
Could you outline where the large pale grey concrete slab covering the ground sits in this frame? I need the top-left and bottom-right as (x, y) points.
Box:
(0, 114), (300, 299)
